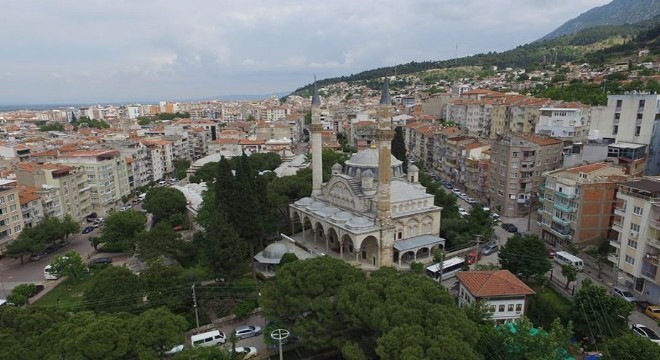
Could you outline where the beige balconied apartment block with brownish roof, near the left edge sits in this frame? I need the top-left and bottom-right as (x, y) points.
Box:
(16, 163), (92, 221)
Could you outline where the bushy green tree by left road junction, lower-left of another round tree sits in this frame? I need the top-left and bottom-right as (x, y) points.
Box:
(99, 210), (147, 250)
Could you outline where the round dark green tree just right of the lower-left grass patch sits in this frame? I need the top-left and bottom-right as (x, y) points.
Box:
(83, 266), (143, 312)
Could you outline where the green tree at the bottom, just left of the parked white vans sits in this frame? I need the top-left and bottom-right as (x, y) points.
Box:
(131, 307), (188, 359)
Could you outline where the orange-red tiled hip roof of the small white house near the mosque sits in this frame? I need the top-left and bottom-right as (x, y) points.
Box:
(456, 270), (535, 298)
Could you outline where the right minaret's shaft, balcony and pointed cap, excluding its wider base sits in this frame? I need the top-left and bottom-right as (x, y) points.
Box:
(376, 78), (394, 225)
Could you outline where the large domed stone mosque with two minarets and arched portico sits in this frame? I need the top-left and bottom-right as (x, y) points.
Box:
(289, 82), (445, 268)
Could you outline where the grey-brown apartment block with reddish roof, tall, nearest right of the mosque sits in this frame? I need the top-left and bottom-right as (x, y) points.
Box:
(488, 134), (563, 217)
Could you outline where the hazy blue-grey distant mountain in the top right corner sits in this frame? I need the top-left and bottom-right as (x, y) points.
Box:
(539, 0), (660, 41)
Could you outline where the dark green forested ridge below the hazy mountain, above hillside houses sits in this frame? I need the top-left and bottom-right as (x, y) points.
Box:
(293, 16), (660, 96)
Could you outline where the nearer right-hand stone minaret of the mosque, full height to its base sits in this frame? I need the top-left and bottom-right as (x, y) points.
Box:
(376, 78), (395, 266)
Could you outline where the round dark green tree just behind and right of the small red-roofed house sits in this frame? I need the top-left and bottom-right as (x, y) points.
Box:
(498, 234), (552, 281)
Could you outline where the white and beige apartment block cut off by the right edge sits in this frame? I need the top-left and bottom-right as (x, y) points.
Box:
(608, 177), (660, 304)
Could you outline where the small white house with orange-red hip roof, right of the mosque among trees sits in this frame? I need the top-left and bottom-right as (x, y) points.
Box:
(456, 270), (535, 324)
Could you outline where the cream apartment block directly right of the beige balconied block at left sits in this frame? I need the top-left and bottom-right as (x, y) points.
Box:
(57, 150), (131, 214)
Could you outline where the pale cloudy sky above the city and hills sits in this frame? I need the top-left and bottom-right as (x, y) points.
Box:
(0, 0), (610, 105)
